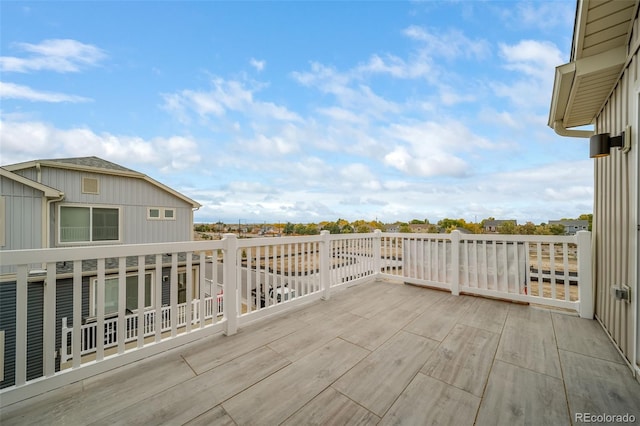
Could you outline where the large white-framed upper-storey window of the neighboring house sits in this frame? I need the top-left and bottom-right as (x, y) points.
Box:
(59, 206), (120, 243)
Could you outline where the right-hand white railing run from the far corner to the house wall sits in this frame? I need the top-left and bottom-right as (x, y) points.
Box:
(381, 231), (593, 312)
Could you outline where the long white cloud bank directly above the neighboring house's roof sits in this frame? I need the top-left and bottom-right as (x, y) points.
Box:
(0, 120), (200, 172)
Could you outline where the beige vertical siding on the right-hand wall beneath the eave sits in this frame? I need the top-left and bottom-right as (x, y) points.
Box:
(593, 10), (640, 365)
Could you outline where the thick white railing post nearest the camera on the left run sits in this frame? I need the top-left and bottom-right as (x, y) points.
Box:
(222, 234), (238, 336)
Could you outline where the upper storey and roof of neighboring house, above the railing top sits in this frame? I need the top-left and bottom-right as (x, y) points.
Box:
(0, 157), (201, 250)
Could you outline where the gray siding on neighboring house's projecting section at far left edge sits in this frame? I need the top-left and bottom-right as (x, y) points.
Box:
(0, 177), (44, 250)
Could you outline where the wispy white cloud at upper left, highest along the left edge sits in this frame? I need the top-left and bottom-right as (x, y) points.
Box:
(0, 39), (107, 73)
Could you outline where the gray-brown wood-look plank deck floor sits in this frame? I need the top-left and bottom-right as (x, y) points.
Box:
(0, 281), (640, 426)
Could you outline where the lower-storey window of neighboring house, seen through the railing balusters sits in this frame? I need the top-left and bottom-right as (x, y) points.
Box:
(91, 272), (153, 316)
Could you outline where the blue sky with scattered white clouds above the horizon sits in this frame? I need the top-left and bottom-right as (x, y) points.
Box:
(0, 0), (593, 224)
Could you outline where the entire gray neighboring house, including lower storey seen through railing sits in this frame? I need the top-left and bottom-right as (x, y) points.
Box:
(0, 157), (206, 388)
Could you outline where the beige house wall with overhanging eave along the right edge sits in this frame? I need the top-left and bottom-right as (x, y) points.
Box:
(549, 0), (640, 376)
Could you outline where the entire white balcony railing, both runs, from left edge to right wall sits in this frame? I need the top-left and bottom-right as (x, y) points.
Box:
(0, 231), (593, 404)
